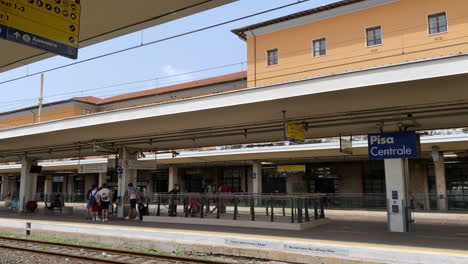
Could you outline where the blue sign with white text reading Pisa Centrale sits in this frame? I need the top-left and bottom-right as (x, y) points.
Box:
(367, 131), (418, 160)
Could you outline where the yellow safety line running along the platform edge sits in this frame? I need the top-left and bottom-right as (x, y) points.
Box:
(0, 218), (468, 255)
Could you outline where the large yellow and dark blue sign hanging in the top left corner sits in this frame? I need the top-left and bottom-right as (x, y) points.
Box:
(0, 0), (81, 59)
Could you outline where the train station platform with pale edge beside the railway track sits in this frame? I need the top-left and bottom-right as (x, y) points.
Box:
(0, 211), (468, 263)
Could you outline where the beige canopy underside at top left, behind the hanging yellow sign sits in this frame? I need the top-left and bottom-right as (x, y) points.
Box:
(0, 0), (237, 72)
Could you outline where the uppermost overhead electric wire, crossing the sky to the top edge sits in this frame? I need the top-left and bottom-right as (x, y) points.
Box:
(0, 0), (311, 85)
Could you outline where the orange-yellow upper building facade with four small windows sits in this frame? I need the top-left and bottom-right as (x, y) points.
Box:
(233, 0), (468, 87)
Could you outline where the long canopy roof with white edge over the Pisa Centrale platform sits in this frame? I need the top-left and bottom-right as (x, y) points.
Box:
(0, 55), (468, 162)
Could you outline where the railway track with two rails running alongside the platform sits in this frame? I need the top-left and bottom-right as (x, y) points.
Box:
(0, 236), (233, 264)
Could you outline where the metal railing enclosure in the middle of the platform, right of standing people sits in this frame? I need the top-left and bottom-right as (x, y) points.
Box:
(145, 193), (325, 223)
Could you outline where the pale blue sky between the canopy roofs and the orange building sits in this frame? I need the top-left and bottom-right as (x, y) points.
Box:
(0, 0), (337, 112)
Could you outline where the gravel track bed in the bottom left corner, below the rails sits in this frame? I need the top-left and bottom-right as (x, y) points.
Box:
(0, 248), (96, 264)
